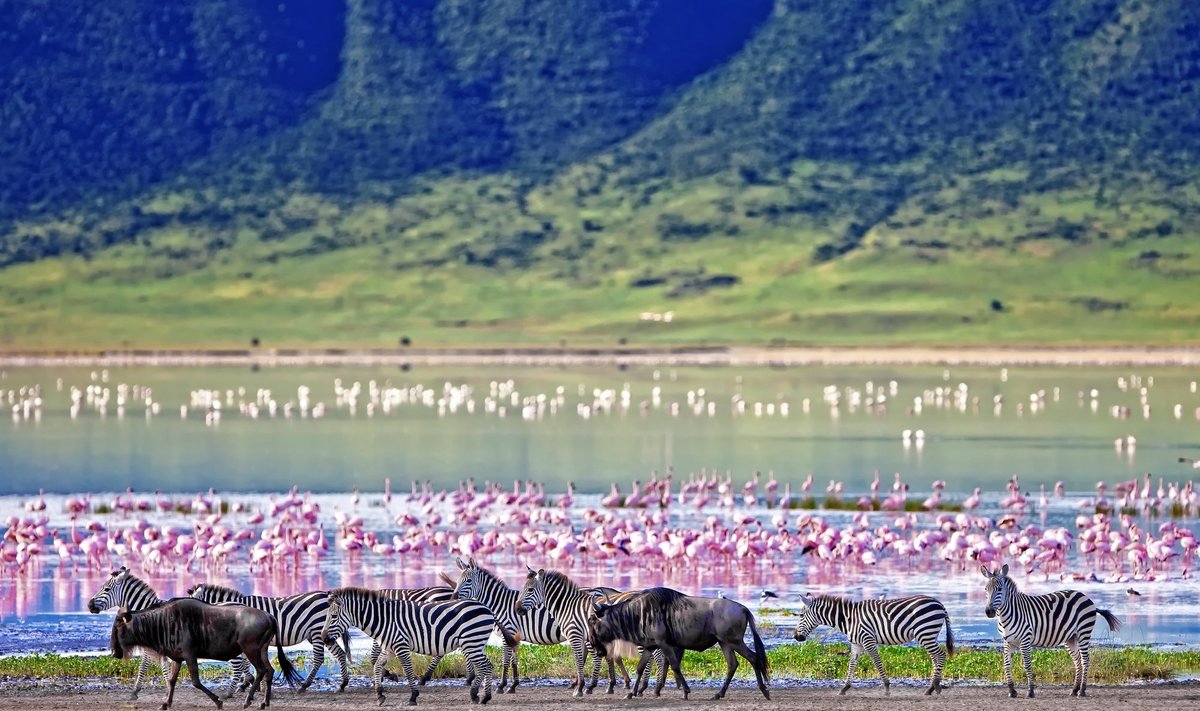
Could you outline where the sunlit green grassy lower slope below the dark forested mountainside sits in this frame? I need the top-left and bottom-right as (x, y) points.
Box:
(0, 165), (1200, 351)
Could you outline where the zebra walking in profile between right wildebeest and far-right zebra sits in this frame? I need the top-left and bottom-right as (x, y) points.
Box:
(792, 595), (954, 695)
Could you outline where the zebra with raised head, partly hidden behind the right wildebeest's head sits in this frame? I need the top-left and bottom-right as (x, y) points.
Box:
(516, 566), (665, 697)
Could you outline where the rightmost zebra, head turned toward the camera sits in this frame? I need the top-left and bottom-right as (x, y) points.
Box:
(979, 563), (1121, 699)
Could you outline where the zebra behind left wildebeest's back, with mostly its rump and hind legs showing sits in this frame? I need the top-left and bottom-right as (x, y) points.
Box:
(187, 582), (350, 693)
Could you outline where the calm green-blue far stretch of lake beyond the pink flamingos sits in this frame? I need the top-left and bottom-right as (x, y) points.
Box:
(0, 368), (1200, 494)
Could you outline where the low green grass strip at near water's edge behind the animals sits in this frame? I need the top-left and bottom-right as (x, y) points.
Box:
(0, 644), (1200, 683)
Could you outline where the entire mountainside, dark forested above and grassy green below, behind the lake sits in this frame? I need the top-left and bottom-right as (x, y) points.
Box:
(0, 0), (1200, 349)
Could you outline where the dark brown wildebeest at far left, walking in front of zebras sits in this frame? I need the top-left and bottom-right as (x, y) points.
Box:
(110, 597), (300, 710)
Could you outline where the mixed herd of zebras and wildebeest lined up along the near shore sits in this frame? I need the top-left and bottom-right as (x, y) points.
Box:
(88, 558), (1120, 709)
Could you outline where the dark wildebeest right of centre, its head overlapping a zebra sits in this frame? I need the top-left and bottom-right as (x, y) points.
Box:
(588, 587), (770, 699)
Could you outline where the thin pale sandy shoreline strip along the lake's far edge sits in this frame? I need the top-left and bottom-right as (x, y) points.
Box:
(0, 346), (1200, 368)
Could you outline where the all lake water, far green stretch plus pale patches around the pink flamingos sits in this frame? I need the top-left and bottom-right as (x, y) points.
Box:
(0, 368), (1200, 653)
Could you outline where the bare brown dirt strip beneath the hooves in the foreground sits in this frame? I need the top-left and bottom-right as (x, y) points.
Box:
(0, 682), (1200, 711)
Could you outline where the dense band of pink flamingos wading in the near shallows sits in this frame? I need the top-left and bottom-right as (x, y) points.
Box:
(0, 471), (1200, 582)
